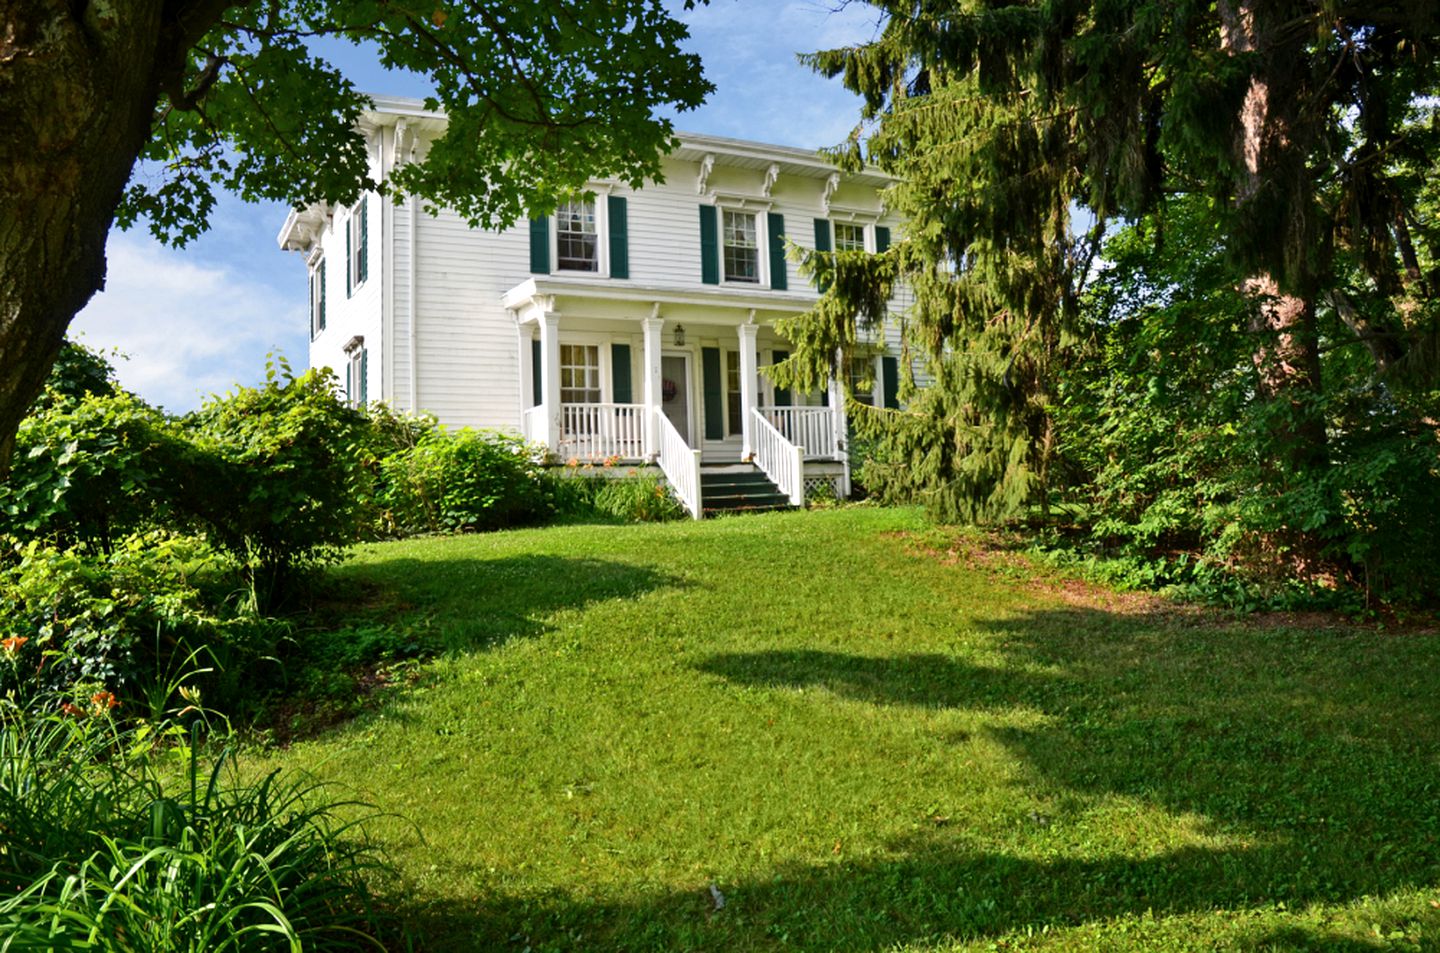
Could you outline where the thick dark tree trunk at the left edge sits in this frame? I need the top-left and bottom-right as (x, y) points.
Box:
(0, 0), (225, 474)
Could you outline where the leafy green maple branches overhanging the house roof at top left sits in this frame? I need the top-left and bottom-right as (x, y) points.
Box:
(118, 0), (711, 242)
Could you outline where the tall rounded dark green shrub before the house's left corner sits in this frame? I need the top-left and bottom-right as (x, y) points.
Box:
(179, 358), (373, 610)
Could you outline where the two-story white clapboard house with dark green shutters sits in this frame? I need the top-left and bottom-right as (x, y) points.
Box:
(279, 98), (899, 517)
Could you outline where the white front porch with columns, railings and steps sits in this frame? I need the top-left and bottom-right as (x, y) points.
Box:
(505, 279), (850, 517)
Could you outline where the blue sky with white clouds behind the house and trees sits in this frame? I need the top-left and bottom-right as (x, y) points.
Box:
(71, 0), (876, 413)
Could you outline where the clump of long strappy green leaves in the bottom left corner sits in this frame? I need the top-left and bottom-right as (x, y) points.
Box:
(0, 700), (384, 953)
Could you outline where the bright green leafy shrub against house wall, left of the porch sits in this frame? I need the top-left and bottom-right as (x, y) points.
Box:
(377, 429), (550, 533)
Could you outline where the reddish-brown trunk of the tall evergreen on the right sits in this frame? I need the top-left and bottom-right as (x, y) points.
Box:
(1217, 0), (1326, 468)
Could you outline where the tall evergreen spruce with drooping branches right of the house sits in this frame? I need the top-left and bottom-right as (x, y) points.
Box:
(780, 0), (1440, 561)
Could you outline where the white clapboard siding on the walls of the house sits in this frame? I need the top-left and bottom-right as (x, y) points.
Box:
(296, 128), (919, 437)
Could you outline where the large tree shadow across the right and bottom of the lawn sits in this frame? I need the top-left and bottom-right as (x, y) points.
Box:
(400, 608), (1440, 950)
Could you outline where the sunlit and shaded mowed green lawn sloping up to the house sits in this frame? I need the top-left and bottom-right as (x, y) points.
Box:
(252, 508), (1440, 950)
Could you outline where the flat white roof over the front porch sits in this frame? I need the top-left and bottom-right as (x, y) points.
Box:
(501, 275), (816, 325)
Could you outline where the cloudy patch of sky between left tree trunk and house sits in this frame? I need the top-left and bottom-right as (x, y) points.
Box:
(71, 233), (307, 413)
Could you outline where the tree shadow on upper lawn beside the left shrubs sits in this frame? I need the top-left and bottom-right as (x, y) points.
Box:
(329, 554), (688, 652)
